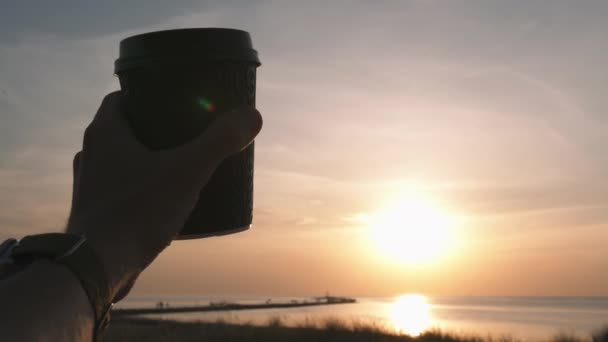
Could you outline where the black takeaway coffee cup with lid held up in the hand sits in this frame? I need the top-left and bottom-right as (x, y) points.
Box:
(115, 28), (260, 239)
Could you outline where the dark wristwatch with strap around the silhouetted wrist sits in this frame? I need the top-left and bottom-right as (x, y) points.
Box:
(0, 233), (113, 341)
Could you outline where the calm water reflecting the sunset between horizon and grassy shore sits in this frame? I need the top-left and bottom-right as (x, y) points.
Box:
(117, 295), (608, 340)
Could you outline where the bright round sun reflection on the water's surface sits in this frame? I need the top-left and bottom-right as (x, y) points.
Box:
(390, 294), (432, 336)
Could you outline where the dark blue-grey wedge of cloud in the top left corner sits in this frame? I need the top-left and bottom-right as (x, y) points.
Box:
(0, 0), (251, 42)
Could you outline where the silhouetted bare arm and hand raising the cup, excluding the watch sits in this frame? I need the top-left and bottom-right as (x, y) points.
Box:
(0, 92), (262, 342)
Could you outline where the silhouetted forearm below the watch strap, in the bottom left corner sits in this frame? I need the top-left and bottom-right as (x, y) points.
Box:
(0, 260), (93, 342)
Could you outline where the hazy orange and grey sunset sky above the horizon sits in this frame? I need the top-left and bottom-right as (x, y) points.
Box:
(0, 0), (608, 296)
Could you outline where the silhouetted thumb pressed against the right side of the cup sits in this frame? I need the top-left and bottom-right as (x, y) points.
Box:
(180, 107), (263, 163)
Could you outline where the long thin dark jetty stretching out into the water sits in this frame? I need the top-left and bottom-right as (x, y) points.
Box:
(112, 296), (357, 317)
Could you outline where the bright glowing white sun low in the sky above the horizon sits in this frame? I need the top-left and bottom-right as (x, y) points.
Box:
(366, 194), (454, 265)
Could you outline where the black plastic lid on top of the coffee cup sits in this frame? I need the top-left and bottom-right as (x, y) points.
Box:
(114, 28), (260, 74)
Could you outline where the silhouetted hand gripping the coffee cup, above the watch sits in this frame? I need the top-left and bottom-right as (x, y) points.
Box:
(67, 92), (262, 301)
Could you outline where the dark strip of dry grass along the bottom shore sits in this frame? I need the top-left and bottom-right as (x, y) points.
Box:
(105, 317), (608, 342)
